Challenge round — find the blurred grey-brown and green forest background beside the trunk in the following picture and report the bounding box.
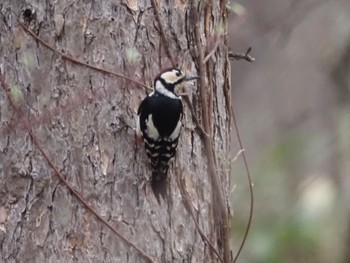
[228,0,350,263]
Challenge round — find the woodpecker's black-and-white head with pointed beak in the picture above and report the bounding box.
[154,68,199,97]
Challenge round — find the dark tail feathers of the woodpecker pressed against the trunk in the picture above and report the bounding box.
[151,163,169,204]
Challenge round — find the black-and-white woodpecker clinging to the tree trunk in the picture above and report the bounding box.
[136,68,199,204]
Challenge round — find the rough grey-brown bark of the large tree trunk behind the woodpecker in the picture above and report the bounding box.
[0,0,231,262]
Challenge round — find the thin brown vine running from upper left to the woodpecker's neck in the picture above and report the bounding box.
[17,20,152,90]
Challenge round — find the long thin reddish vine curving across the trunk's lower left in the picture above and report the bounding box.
[0,72,155,262]
